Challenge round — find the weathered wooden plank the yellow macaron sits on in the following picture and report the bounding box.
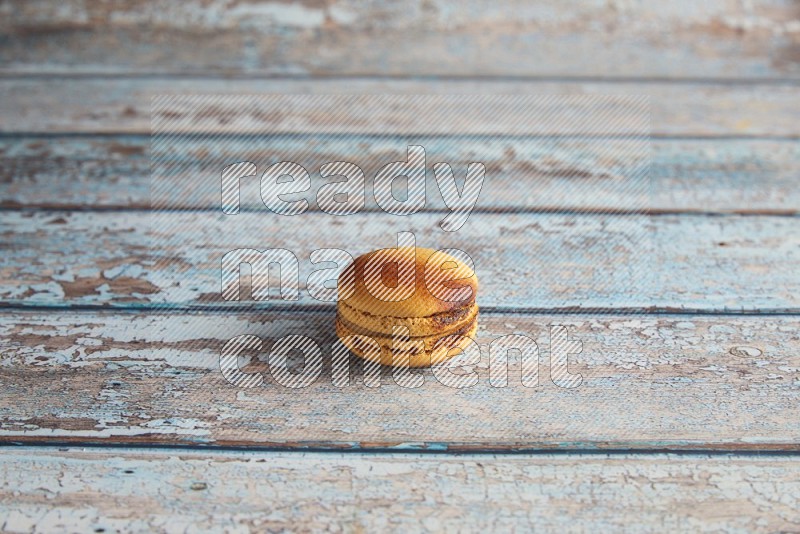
[0,311,800,451]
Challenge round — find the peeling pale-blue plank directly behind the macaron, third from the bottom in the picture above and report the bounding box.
[0,213,800,312]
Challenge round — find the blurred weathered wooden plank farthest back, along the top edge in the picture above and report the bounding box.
[0,0,800,79]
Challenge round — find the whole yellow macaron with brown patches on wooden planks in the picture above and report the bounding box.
[336,247,478,367]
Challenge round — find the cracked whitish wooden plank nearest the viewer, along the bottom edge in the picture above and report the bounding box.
[0,448,800,532]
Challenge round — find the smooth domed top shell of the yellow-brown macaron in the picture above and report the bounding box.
[338,247,478,317]
